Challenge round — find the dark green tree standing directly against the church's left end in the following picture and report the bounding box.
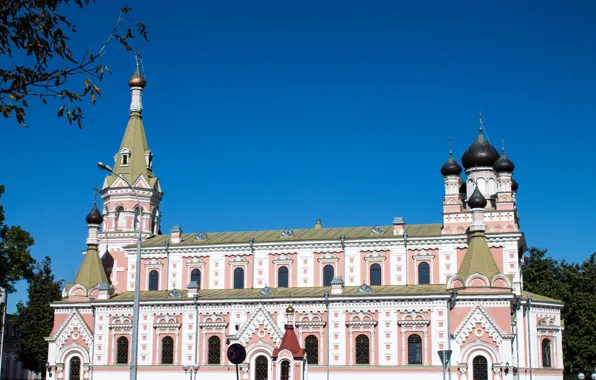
[14,256,62,378]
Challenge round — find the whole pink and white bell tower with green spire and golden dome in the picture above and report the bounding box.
[99,64,163,264]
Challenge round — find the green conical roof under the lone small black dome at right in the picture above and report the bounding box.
[457,232,500,281]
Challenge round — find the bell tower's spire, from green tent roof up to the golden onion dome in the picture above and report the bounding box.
[108,57,157,187]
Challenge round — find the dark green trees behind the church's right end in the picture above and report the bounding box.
[522,248,596,378]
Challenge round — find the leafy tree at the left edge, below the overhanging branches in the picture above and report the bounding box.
[0,185,35,293]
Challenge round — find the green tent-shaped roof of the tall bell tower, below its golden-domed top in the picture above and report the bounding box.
[108,112,156,186]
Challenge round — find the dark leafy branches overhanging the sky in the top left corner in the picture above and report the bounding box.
[0,0,147,128]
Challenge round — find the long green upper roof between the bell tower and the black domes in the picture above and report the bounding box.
[136,223,443,247]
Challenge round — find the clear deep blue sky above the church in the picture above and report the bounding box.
[0,0,596,310]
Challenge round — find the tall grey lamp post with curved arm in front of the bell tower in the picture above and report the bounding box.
[97,162,143,380]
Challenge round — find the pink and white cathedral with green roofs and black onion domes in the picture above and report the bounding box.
[46,69,563,380]
